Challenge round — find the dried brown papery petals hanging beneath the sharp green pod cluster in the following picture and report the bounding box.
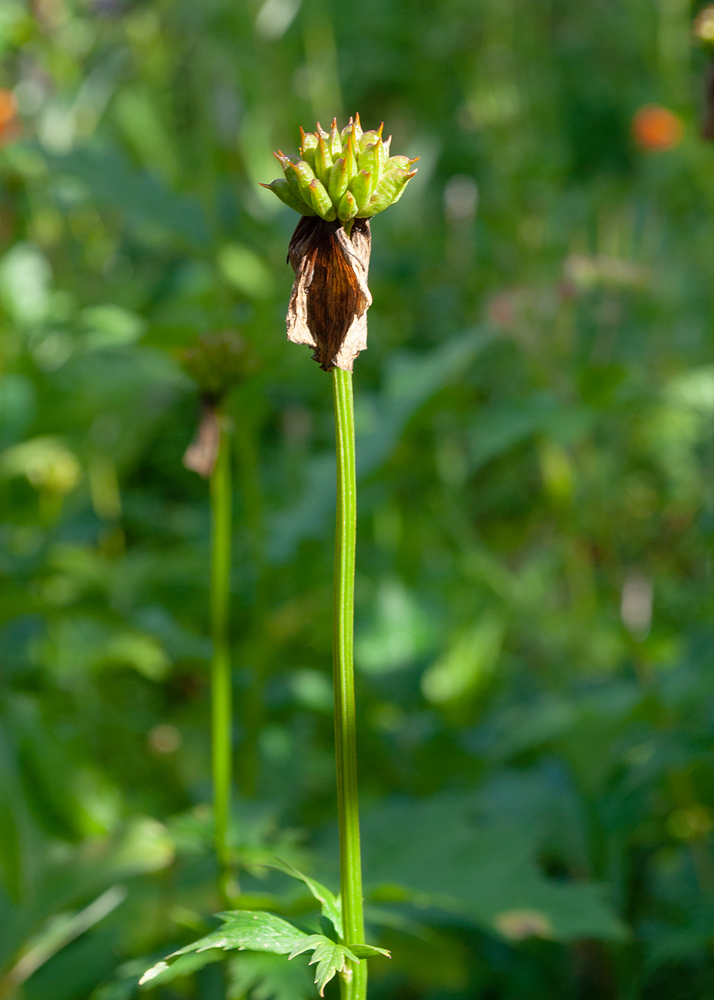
[287,217,372,371]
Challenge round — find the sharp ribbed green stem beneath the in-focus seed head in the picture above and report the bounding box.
[332,368,367,1000]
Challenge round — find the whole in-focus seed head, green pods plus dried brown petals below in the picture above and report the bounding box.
[263,115,416,371]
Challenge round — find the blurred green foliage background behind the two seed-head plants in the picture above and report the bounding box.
[0,0,714,1000]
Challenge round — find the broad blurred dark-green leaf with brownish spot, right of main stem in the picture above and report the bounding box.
[362,793,627,941]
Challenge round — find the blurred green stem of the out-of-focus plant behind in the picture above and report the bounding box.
[210,413,233,904]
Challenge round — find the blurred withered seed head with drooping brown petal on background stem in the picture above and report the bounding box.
[180,330,253,478]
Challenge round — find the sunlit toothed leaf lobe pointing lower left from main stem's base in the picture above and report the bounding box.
[139,910,305,985]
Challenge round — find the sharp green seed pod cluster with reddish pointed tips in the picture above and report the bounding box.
[262,115,419,235]
